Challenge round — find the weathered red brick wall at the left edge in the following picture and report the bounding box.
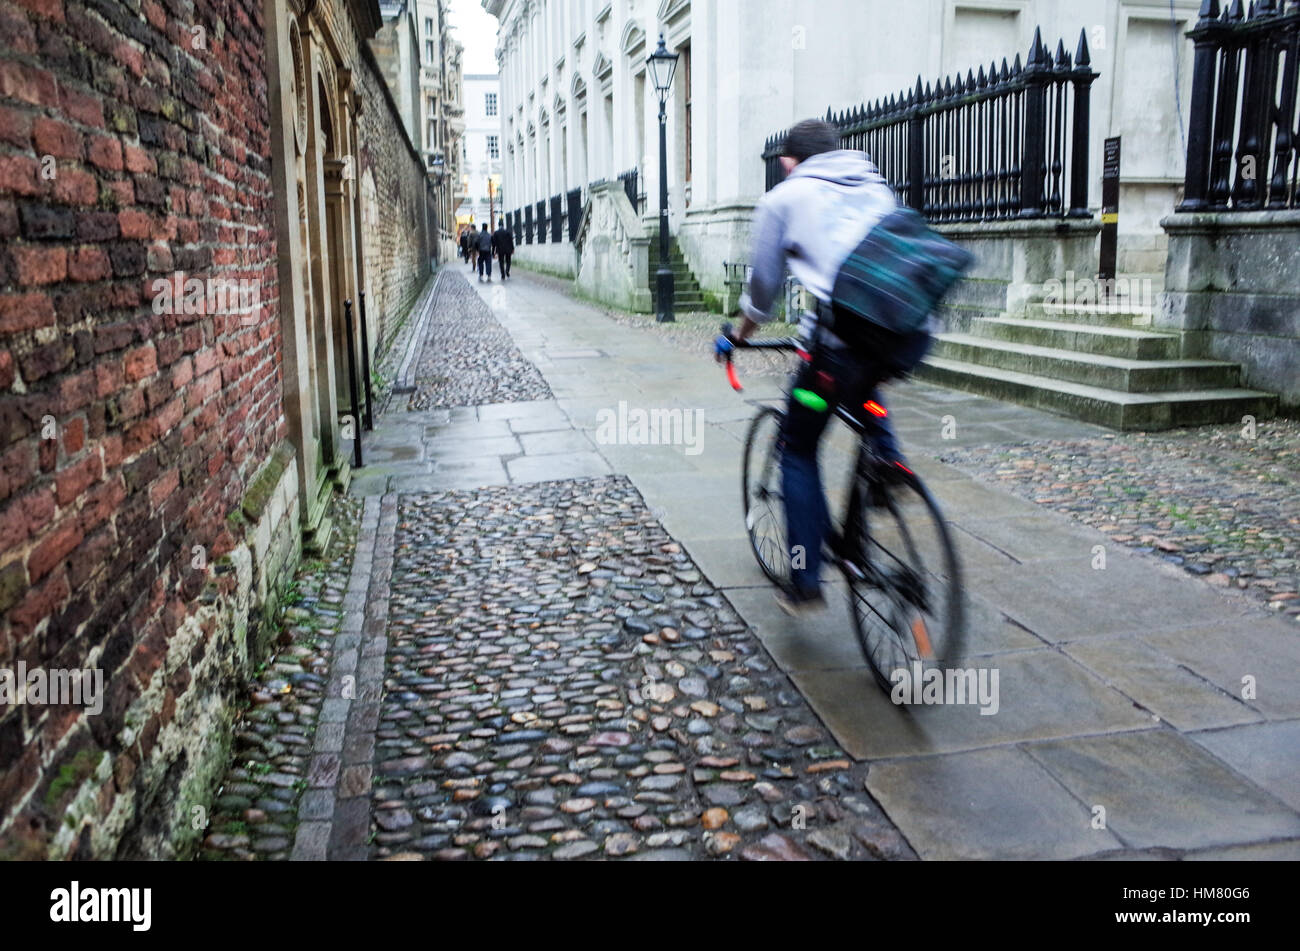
[0,0,286,854]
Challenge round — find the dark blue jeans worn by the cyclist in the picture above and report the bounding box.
[781,334,930,596]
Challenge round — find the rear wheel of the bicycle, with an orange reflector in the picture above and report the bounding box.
[845,473,965,691]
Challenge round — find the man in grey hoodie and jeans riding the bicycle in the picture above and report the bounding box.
[718,120,930,615]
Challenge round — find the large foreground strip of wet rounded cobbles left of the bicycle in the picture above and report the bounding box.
[372,477,914,860]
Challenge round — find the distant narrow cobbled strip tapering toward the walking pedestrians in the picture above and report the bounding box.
[408,271,551,409]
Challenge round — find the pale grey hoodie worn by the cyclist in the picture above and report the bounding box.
[740,149,897,335]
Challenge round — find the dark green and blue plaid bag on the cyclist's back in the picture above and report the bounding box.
[829,208,975,372]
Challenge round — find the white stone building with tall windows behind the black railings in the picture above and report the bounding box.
[482,0,1200,292]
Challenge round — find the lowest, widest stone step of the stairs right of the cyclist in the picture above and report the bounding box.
[917,356,1278,431]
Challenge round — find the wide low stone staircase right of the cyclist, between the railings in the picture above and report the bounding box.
[917,289,1278,430]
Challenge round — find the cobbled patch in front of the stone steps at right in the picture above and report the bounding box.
[941,420,1300,620]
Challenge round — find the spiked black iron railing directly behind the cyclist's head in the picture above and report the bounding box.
[763,30,1097,221]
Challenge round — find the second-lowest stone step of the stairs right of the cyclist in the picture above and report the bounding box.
[931,334,1242,392]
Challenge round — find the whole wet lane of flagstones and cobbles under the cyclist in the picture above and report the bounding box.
[205,266,1300,860]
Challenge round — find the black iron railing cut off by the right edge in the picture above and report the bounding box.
[1178,0,1300,212]
